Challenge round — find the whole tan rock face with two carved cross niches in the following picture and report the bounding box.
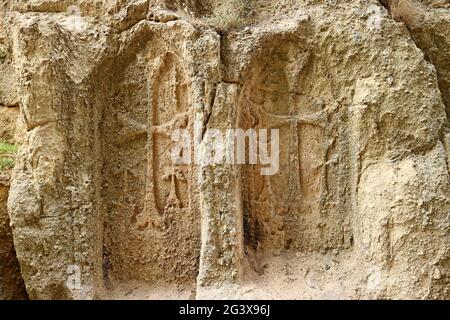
[0,0,450,299]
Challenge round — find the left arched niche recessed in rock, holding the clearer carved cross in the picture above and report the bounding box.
[103,41,200,296]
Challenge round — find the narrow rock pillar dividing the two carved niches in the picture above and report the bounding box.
[197,83,243,299]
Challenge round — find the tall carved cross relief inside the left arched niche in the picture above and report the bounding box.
[116,53,189,230]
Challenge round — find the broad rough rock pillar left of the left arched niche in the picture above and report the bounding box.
[8,13,107,299]
